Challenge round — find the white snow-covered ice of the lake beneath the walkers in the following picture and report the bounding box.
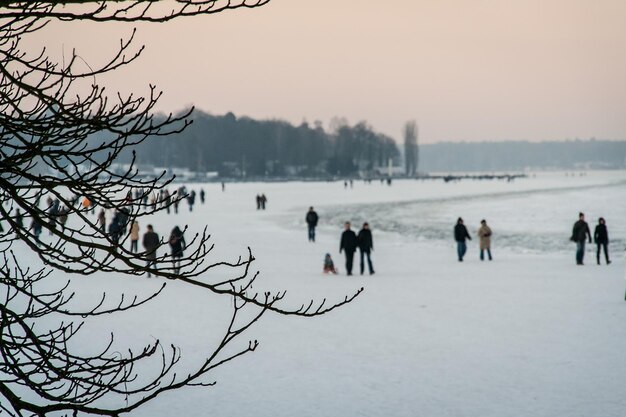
[9,172,626,417]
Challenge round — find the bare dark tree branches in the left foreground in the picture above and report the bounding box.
[0,0,361,416]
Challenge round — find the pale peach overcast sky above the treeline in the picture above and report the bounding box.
[29,0,626,143]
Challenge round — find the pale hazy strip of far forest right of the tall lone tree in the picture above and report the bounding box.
[419,139,626,173]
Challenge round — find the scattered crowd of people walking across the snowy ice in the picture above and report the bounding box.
[0,181,611,282]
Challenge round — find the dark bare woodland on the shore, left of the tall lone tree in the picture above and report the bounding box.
[126,112,400,177]
